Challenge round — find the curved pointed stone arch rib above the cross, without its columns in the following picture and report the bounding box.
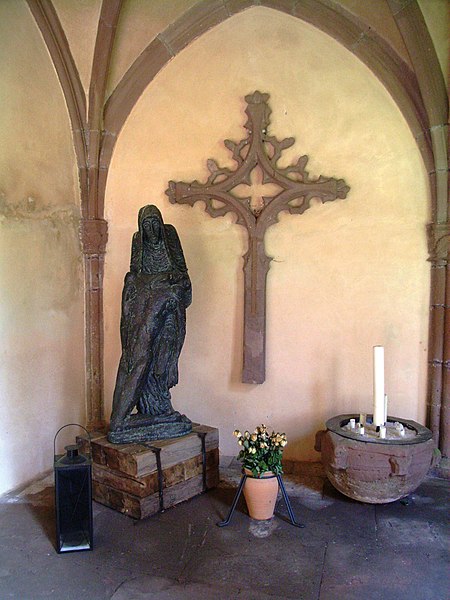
[99,0,433,209]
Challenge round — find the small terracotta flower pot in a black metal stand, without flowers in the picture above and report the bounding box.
[244,469,278,521]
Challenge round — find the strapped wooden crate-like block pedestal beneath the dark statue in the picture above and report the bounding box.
[79,425,219,519]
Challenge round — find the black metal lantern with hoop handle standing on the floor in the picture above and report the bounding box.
[53,423,93,553]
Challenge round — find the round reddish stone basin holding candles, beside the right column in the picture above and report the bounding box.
[316,414,435,504]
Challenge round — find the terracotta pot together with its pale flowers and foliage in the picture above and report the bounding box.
[234,425,287,520]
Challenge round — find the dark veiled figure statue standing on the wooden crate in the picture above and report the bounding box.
[108,205,192,443]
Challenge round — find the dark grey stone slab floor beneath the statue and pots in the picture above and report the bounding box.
[0,459,450,600]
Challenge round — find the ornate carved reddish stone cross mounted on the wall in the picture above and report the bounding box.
[166,92,350,383]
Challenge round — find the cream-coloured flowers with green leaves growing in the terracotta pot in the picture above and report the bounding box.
[234,425,287,477]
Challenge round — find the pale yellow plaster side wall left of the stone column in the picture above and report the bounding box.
[0,1,85,494]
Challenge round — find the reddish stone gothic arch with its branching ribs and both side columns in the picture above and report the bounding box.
[27,0,450,456]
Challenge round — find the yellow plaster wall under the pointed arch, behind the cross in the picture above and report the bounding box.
[104,7,429,460]
